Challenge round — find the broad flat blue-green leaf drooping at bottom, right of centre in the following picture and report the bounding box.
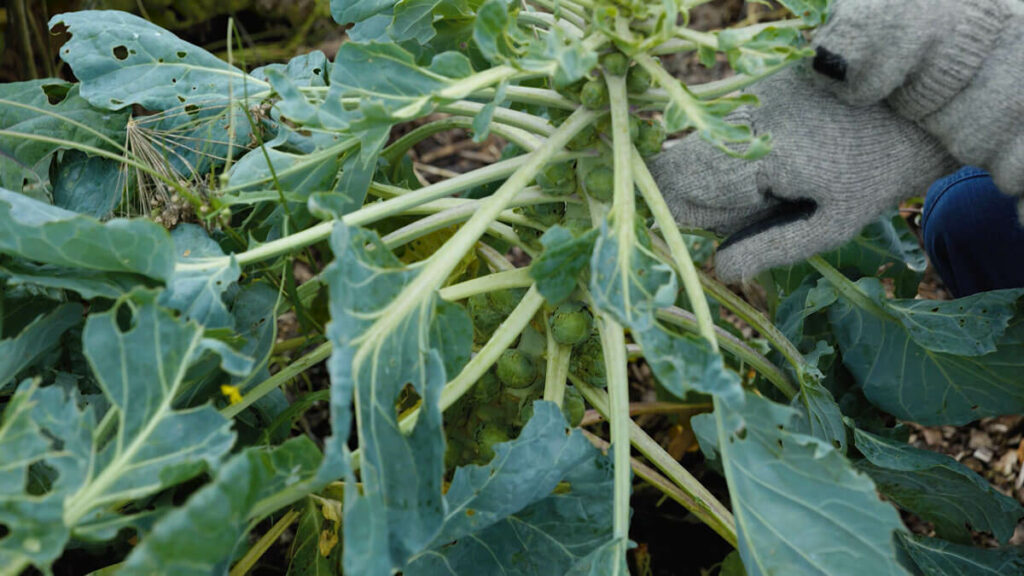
[693,394,906,576]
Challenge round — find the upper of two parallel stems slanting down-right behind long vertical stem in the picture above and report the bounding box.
[569,379,736,546]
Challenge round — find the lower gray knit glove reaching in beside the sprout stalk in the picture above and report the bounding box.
[648,70,956,282]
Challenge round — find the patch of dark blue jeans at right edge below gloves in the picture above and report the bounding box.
[921,166,1024,297]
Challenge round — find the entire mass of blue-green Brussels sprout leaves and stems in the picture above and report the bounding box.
[0,0,1024,576]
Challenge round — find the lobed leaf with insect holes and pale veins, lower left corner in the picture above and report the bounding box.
[0,291,245,569]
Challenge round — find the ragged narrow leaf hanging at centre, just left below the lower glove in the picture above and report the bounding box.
[590,224,742,399]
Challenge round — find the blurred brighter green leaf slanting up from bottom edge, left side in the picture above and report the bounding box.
[118,437,321,576]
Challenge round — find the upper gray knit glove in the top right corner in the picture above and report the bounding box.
[814,0,1024,199]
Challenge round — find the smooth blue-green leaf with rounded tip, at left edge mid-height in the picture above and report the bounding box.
[0,189,174,280]
